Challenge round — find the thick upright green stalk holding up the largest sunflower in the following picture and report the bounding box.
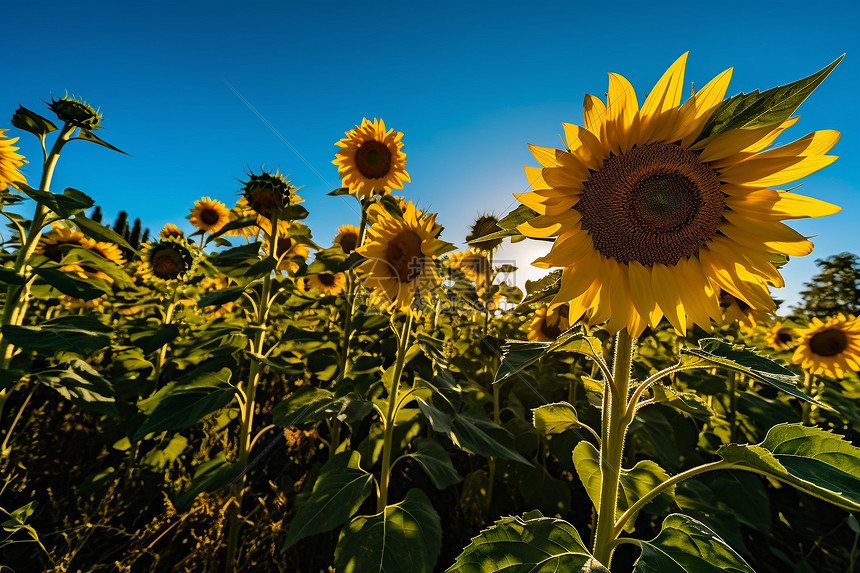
[594,330,633,567]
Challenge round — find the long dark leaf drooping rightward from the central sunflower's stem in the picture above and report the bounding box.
[416,398,531,465]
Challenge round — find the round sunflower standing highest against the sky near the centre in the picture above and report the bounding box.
[332,118,409,199]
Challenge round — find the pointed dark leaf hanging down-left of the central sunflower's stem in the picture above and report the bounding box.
[281,452,373,552]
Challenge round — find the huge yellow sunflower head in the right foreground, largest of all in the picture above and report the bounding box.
[516,54,839,336]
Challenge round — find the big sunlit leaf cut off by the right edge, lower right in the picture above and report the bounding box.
[717,424,860,511]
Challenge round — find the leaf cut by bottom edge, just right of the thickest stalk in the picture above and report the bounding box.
[633,513,755,573]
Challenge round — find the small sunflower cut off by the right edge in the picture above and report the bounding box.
[792,312,860,378]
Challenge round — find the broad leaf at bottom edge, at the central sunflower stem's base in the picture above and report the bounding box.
[334,489,442,573]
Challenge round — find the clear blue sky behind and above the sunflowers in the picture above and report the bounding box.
[0,0,860,310]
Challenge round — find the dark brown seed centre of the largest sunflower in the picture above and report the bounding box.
[574,143,726,265]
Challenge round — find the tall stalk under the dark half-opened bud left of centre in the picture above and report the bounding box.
[225,211,278,573]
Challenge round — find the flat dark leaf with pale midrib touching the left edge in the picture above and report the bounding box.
[0,316,113,353]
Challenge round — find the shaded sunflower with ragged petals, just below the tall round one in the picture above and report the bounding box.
[356,199,450,310]
